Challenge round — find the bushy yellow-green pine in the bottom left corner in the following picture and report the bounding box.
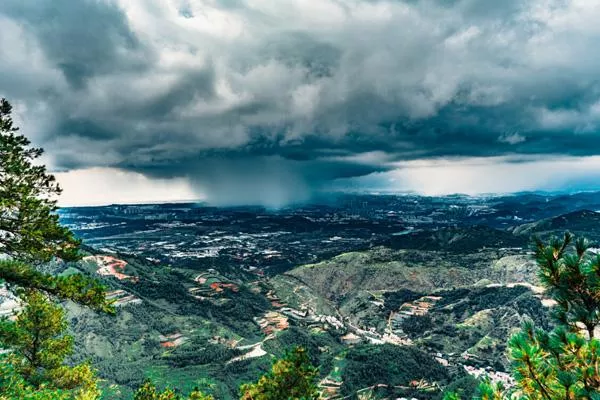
[0,290,99,399]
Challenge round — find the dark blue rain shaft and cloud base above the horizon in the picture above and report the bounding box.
[124,154,389,207]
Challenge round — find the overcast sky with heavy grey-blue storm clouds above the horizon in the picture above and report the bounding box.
[0,0,600,206]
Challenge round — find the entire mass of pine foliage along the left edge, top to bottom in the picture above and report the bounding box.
[0,99,113,400]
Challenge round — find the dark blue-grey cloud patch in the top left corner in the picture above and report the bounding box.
[1,0,144,88]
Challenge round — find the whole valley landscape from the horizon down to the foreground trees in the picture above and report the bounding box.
[11,193,600,399]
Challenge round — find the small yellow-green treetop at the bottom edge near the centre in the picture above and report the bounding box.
[240,347,319,400]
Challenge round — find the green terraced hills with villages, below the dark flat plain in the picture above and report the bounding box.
[61,238,543,399]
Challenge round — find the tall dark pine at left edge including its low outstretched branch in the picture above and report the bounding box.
[0,99,111,311]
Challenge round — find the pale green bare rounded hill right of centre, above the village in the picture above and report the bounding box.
[288,248,536,301]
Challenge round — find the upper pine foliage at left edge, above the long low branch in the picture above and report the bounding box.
[0,99,79,262]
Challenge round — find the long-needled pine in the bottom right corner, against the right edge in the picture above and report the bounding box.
[445,233,600,400]
